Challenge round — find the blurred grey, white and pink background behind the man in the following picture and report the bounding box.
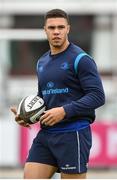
[0,0,117,179]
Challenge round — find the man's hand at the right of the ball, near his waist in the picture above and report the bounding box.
[40,107,65,126]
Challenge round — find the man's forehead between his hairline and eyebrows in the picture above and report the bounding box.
[45,17,68,26]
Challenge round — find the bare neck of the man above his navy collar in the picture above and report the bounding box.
[50,40,69,55]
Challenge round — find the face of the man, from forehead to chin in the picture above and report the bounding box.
[44,18,70,48]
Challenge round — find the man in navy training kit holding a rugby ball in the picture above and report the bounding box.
[11,9,105,179]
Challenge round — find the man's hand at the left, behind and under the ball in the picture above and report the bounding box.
[10,107,30,128]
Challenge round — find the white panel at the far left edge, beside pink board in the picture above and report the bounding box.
[0,111,19,166]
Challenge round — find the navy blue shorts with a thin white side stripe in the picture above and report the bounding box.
[27,126,92,174]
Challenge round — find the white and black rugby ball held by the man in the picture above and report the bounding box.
[17,95,46,124]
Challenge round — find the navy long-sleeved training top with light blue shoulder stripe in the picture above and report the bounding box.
[37,43,105,131]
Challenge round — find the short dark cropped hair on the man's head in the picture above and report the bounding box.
[44,9,70,24]
